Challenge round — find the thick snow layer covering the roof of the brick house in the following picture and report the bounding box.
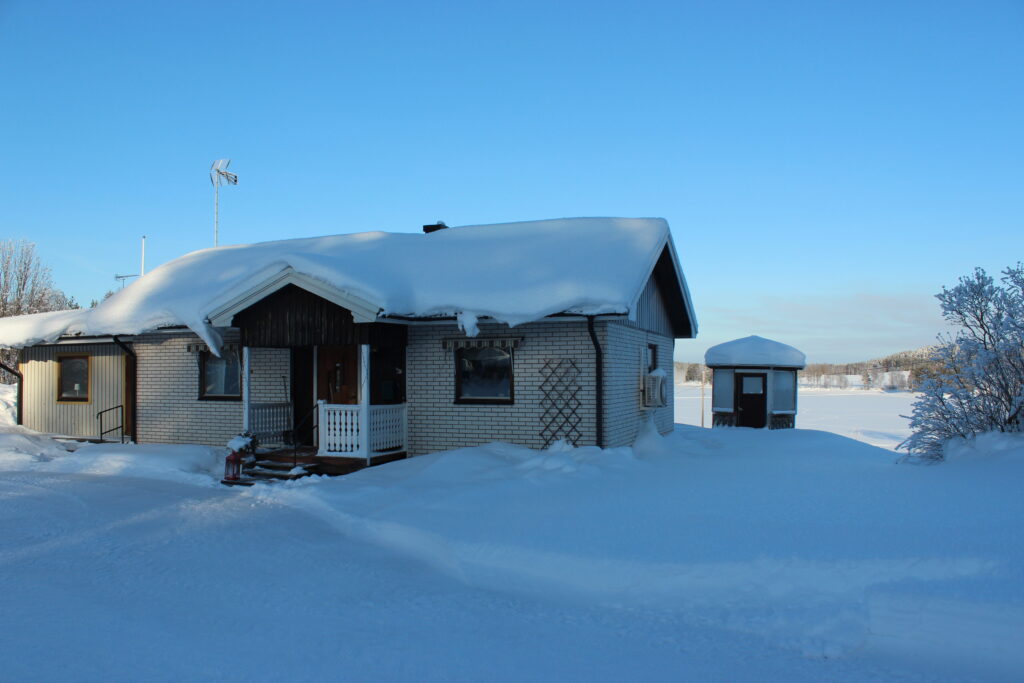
[0,218,696,347]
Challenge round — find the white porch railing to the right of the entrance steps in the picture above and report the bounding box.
[318,402,406,458]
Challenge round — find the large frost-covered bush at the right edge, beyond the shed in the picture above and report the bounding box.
[899,263,1024,462]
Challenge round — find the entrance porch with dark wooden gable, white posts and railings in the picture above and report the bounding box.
[218,283,409,485]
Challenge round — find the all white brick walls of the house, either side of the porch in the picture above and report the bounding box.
[134,321,673,455]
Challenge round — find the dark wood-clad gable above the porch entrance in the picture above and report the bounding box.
[231,285,407,348]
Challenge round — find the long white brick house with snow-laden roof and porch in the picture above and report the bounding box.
[0,218,696,458]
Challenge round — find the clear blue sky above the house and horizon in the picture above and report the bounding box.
[0,0,1024,361]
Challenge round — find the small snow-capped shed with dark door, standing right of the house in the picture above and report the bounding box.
[705,336,807,429]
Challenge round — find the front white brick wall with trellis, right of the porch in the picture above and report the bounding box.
[406,322,596,455]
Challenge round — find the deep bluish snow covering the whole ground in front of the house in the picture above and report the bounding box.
[0,392,1024,681]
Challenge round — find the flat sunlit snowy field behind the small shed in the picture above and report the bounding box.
[676,384,914,449]
